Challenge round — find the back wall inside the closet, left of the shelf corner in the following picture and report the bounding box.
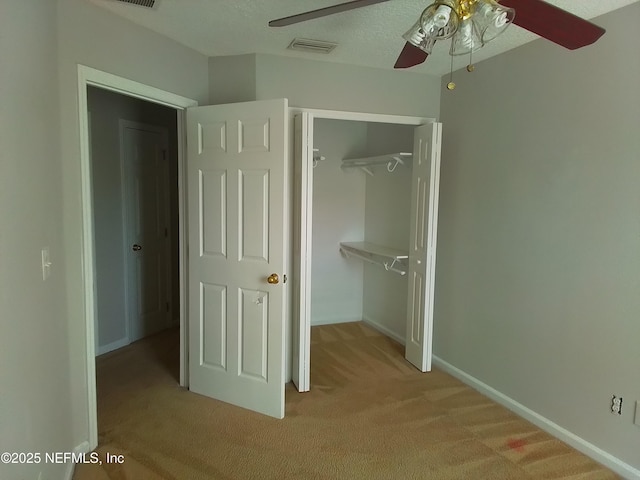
[311,119,367,325]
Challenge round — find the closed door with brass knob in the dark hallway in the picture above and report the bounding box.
[120,120,171,342]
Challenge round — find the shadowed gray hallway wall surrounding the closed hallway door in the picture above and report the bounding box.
[88,87,180,353]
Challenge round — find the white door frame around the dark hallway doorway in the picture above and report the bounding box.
[78,65,198,450]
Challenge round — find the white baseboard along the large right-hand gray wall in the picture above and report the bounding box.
[433,355,640,480]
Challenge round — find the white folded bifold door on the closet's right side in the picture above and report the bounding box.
[405,123,442,372]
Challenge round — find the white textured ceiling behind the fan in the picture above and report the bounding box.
[89,0,640,76]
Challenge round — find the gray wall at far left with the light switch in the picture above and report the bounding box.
[0,0,75,479]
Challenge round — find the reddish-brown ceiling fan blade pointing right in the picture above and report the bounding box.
[500,0,605,50]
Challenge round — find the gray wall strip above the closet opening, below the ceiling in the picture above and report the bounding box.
[209,54,440,117]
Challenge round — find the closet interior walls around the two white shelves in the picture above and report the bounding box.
[311,119,414,342]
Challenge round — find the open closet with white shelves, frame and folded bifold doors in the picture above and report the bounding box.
[292,111,441,391]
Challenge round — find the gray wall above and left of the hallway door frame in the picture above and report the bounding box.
[56,0,209,454]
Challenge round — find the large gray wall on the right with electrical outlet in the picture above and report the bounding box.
[434,3,640,468]
